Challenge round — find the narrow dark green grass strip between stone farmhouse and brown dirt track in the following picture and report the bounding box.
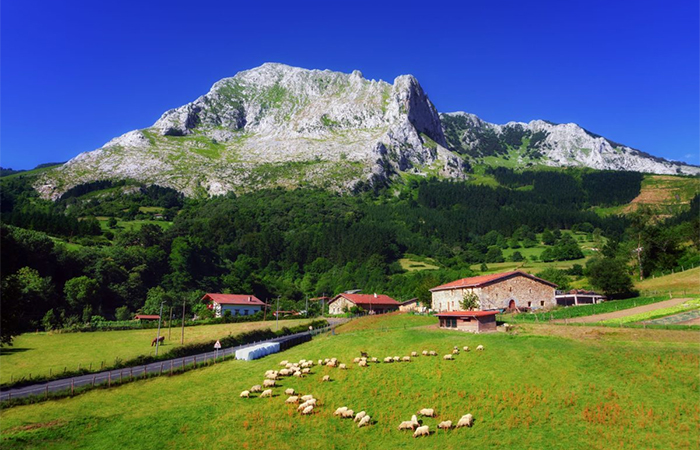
[497,295,680,322]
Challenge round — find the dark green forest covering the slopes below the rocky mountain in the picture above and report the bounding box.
[0,169,700,342]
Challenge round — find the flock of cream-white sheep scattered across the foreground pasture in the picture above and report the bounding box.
[240,345,484,438]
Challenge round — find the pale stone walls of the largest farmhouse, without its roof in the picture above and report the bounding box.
[433,276,556,312]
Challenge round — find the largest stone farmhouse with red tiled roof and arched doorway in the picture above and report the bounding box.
[430,270,557,312]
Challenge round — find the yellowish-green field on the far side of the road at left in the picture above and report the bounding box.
[0,320,308,383]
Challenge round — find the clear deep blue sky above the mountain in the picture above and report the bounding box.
[0,0,700,169]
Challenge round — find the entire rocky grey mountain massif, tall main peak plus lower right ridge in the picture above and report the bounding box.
[35,63,700,199]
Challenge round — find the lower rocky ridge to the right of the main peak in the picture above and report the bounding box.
[440,112,700,175]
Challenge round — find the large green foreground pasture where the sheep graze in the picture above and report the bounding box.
[0,316,700,449]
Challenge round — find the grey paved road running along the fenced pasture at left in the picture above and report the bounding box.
[0,319,344,401]
